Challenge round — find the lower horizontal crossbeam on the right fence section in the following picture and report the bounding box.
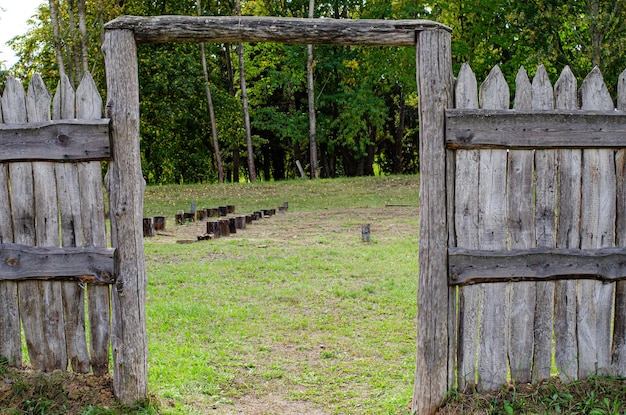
[448,248,626,285]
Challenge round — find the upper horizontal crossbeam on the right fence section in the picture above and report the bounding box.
[446,110,626,149]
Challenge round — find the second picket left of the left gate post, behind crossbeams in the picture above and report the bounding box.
[52,75,90,373]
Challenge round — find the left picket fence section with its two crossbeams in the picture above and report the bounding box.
[0,74,114,375]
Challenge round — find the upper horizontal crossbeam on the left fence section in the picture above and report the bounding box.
[0,119,111,162]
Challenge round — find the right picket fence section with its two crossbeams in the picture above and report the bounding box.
[446,65,626,390]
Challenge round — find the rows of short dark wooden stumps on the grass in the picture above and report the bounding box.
[143,202,289,240]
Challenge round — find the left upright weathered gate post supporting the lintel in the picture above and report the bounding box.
[102,30,148,404]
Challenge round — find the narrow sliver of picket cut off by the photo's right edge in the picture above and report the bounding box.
[611,70,626,376]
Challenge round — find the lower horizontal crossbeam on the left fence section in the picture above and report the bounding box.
[0,243,115,284]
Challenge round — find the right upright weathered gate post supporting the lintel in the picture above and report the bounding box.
[412,29,453,415]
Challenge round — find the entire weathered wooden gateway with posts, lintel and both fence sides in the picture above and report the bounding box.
[7,11,626,414]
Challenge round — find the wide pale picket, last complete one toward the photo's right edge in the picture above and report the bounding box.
[577,67,616,378]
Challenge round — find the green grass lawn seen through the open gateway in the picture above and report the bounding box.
[146,176,419,414]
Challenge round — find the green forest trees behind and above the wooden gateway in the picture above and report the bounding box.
[0,0,626,184]
